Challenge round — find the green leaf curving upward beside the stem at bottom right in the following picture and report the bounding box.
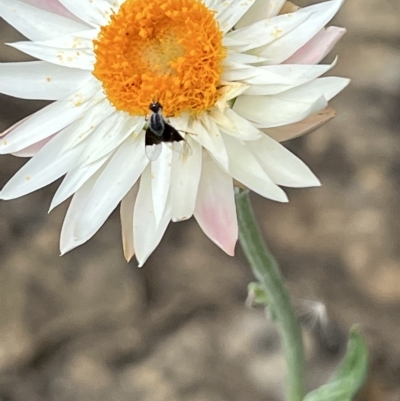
[303,327,368,401]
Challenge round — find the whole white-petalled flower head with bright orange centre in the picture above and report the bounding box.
[0,0,348,265]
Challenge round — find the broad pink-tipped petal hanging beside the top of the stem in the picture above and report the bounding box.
[194,151,238,256]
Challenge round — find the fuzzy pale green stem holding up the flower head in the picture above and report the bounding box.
[236,190,305,401]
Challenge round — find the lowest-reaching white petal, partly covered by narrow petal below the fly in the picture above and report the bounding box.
[133,166,171,267]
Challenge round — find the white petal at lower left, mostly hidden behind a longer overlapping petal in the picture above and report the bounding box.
[60,170,101,255]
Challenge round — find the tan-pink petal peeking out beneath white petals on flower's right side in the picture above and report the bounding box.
[261,106,336,142]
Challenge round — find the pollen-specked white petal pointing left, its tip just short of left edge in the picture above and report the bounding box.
[8,29,97,71]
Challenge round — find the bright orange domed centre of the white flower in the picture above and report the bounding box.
[93,0,226,116]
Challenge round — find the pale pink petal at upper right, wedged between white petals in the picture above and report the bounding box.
[283,26,346,64]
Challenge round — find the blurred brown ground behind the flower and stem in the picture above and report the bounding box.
[0,0,400,401]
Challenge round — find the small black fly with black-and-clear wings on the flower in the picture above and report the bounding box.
[145,102,190,161]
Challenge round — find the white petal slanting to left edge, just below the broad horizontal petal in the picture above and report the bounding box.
[0,82,101,154]
